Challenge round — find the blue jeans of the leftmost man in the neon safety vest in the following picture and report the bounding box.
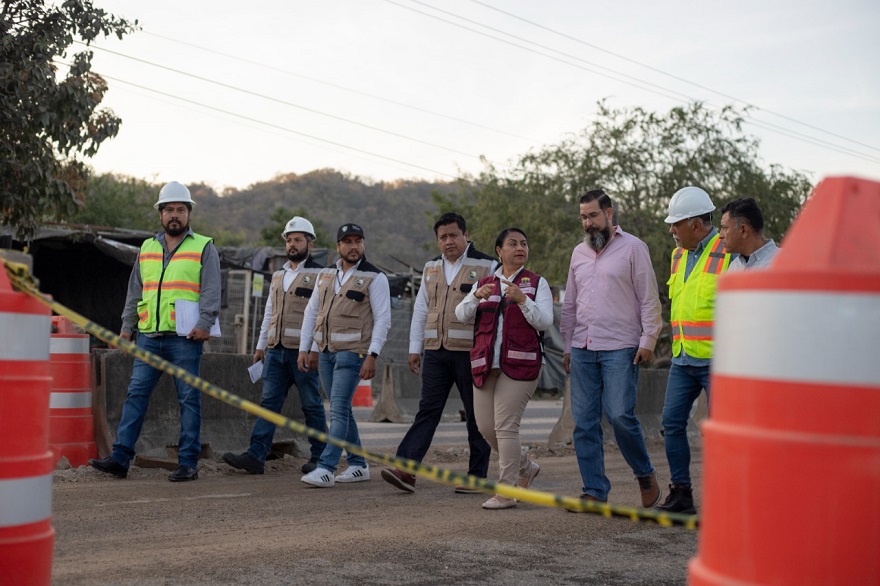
[110,335,204,468]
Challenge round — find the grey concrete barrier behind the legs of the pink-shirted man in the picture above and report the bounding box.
[547,368,708,447]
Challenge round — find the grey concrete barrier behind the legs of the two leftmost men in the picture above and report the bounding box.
[92,350,309,457]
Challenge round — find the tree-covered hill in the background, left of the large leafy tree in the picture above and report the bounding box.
[69,169,451,271]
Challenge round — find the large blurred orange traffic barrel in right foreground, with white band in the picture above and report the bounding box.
[689,177,880,585]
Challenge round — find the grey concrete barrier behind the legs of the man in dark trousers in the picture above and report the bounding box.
[370,362,464,423]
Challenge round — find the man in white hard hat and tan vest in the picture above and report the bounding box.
[223,216,327,474]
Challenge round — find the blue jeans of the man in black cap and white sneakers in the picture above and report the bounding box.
[318,350,367,472]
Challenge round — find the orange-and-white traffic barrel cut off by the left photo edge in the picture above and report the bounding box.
[0,269,55,584]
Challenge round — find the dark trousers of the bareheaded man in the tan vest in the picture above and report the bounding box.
[397,348,492,478]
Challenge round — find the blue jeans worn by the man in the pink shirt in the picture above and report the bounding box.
[570,348,654,501]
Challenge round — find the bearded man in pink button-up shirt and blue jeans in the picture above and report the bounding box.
[559,189,662,507]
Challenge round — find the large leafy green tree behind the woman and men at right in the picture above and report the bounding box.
[434,101,812,293]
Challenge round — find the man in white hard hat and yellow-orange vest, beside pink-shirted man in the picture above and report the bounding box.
[657,186,730,514]
